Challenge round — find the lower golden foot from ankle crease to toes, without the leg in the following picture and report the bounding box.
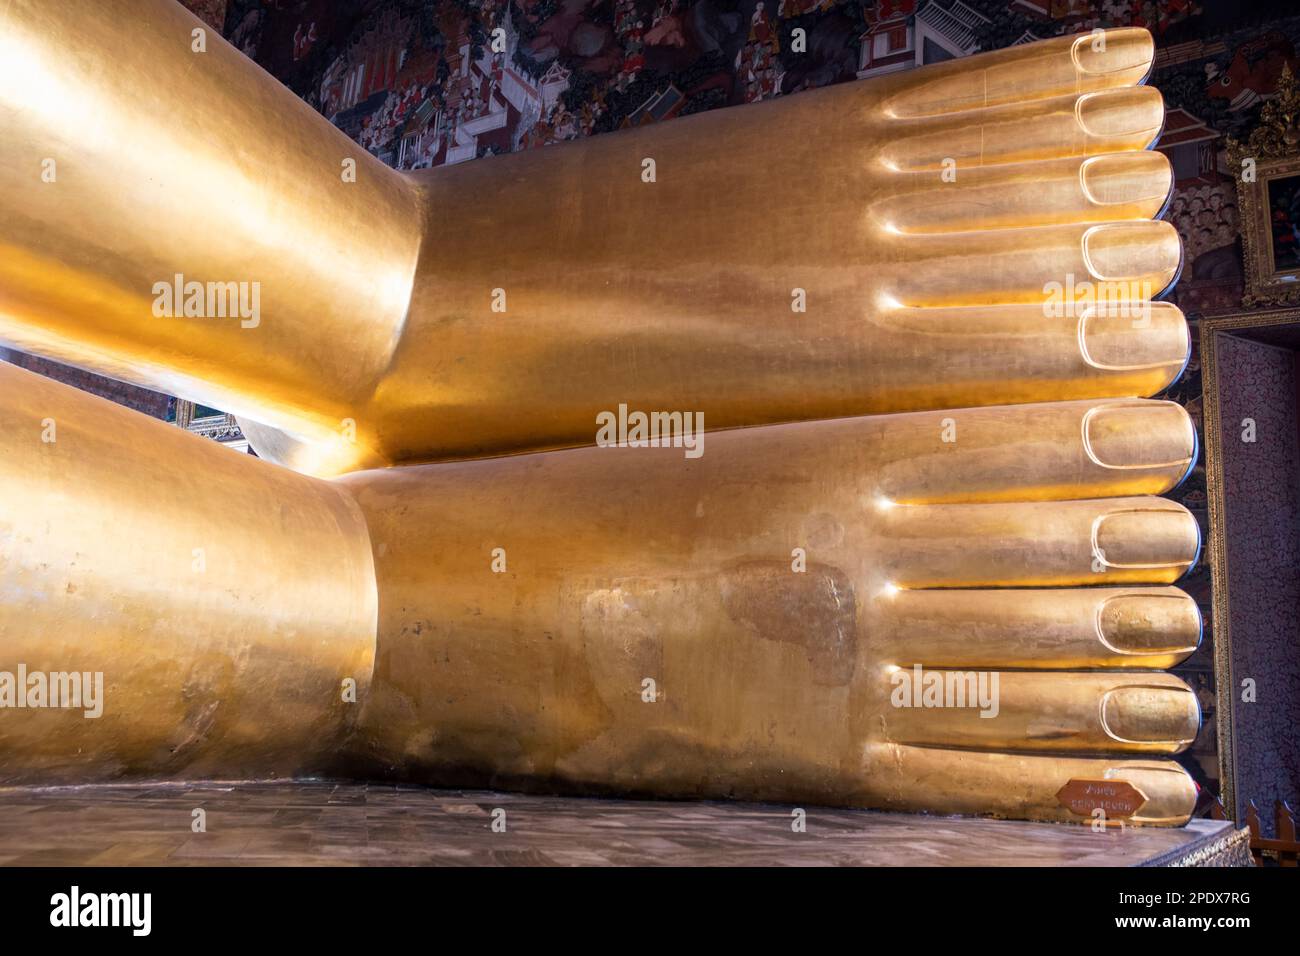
[342,399,1200,825]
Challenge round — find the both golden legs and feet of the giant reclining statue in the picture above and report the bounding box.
[0,0,1201,825]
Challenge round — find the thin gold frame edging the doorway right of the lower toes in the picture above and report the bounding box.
[1200,308,1300,821]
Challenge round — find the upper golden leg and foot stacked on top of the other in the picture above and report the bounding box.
[0,0,1190,475]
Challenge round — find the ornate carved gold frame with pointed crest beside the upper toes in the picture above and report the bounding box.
[1227,68,1300,306]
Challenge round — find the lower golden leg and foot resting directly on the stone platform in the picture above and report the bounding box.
[0,367,1200,825]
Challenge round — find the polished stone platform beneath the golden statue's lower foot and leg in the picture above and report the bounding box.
[0,782,1249,866]
